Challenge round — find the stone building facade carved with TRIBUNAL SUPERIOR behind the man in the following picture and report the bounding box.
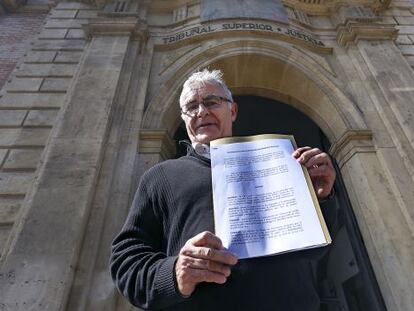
[0,0,414,311]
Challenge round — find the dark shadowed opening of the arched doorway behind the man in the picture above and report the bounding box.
[174,95,386,311]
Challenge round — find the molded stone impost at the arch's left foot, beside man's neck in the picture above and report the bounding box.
[138,129,176,159]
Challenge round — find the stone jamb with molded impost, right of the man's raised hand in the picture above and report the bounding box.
[331,131,414,311]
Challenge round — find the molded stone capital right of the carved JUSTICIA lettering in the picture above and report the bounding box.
[336,20,398,47]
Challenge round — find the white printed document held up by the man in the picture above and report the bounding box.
[210,135,331,259]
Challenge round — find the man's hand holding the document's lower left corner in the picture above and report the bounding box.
[175,231,237,296]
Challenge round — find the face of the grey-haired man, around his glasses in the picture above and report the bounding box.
[181,84,237,144]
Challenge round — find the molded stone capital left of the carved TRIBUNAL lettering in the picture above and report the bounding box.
[82,17,147,40]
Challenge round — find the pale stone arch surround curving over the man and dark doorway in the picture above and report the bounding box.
[139,37,414,310]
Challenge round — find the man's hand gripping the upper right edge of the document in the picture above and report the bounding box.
[292,147,336,199]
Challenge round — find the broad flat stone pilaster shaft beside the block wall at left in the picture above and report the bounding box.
[0,22,130,311]
